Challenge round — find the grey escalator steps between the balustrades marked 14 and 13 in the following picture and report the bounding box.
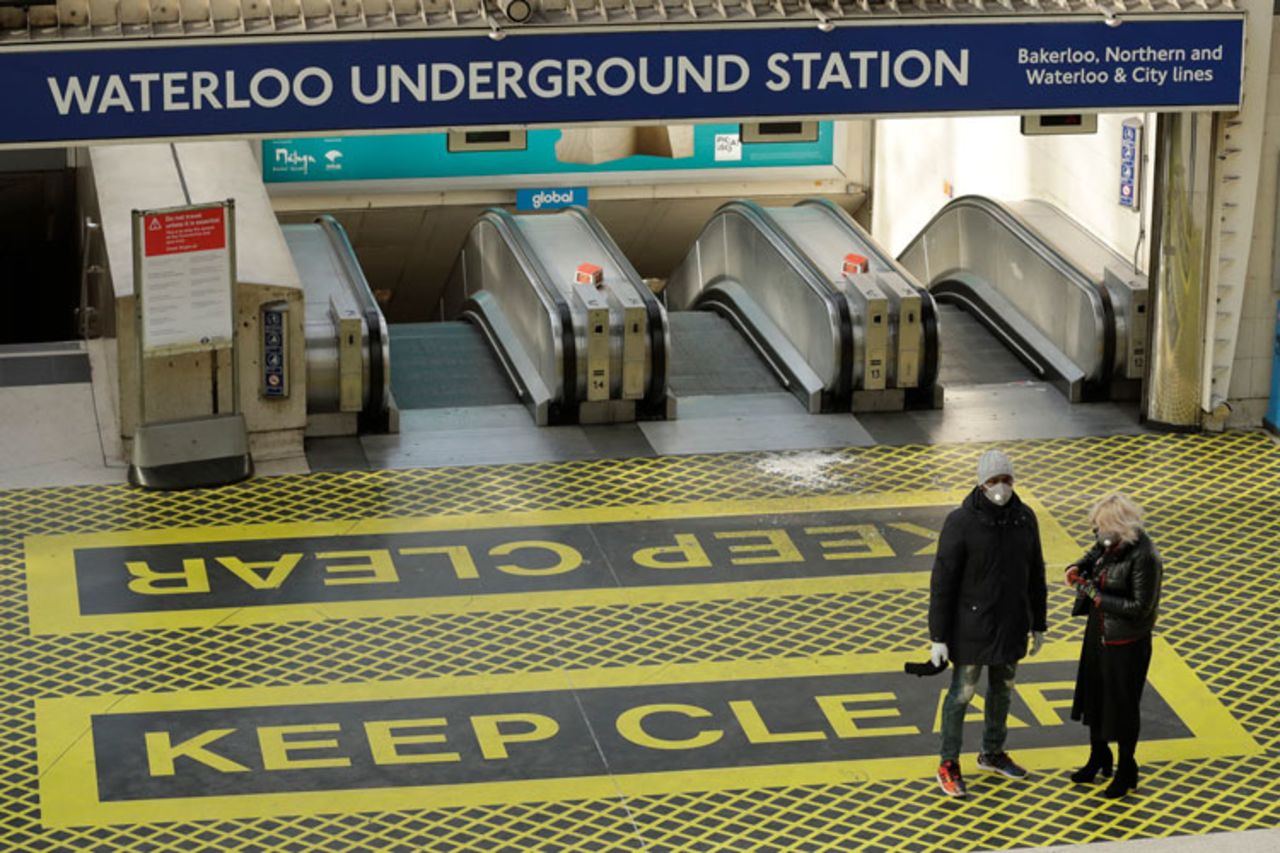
[668,311,778,397]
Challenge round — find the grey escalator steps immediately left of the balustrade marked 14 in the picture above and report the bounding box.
[390,321,520,409]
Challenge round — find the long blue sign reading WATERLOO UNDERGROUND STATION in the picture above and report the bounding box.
[0,15,1244,145]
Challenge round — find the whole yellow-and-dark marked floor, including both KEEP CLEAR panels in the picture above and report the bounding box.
[0,433,1280,850]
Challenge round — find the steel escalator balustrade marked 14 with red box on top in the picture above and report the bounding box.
[442,207,669,425]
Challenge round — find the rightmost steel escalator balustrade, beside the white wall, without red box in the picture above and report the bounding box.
[899,196,1147,402]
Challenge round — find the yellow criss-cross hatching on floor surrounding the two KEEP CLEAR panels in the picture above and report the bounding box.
[0,433,1280,850]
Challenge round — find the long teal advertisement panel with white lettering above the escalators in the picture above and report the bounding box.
[262,122,835,183]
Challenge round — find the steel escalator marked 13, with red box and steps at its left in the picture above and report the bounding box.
[666,200,937,414]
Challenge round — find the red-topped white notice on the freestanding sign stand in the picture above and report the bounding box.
[133,202,234,355]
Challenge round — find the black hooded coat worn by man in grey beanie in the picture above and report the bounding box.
[929,487,1047,663]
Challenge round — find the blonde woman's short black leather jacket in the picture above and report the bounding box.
[1071,533,1165,643]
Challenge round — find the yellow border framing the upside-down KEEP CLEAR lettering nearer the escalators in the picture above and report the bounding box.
[26,491,1080,634]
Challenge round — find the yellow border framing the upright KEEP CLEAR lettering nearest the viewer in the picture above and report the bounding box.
[36,639,1260,826]
